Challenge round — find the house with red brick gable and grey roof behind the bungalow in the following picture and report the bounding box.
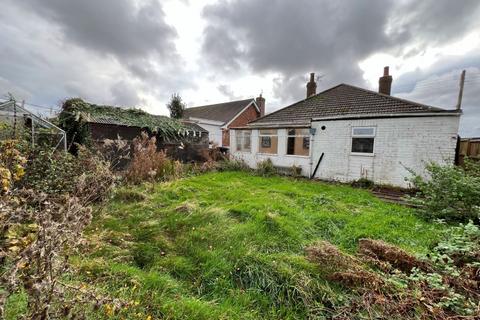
[183,95,265,148]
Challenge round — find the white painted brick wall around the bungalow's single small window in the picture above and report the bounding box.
[312,116,460,187]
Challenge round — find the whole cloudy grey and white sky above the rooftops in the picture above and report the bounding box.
[0,0,480,136]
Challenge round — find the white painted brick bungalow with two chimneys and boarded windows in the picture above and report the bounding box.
[230,67,462,187]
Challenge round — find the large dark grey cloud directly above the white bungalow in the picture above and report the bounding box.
[203,0,390,83]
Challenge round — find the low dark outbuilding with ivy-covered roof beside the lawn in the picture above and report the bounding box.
[58,98,209,161]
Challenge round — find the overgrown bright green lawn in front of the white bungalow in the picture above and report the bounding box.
[74,172,443,319]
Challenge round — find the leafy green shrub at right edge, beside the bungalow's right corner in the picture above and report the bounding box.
[411,163,480,222]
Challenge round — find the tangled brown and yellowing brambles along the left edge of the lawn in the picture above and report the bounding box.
[0,140,116,319]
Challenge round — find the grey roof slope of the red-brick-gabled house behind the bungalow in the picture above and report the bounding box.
[183,98,254,123]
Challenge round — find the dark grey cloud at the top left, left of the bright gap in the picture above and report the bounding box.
[17,0,176,58]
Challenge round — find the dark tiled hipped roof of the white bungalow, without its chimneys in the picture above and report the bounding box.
[250,83,456,125]
